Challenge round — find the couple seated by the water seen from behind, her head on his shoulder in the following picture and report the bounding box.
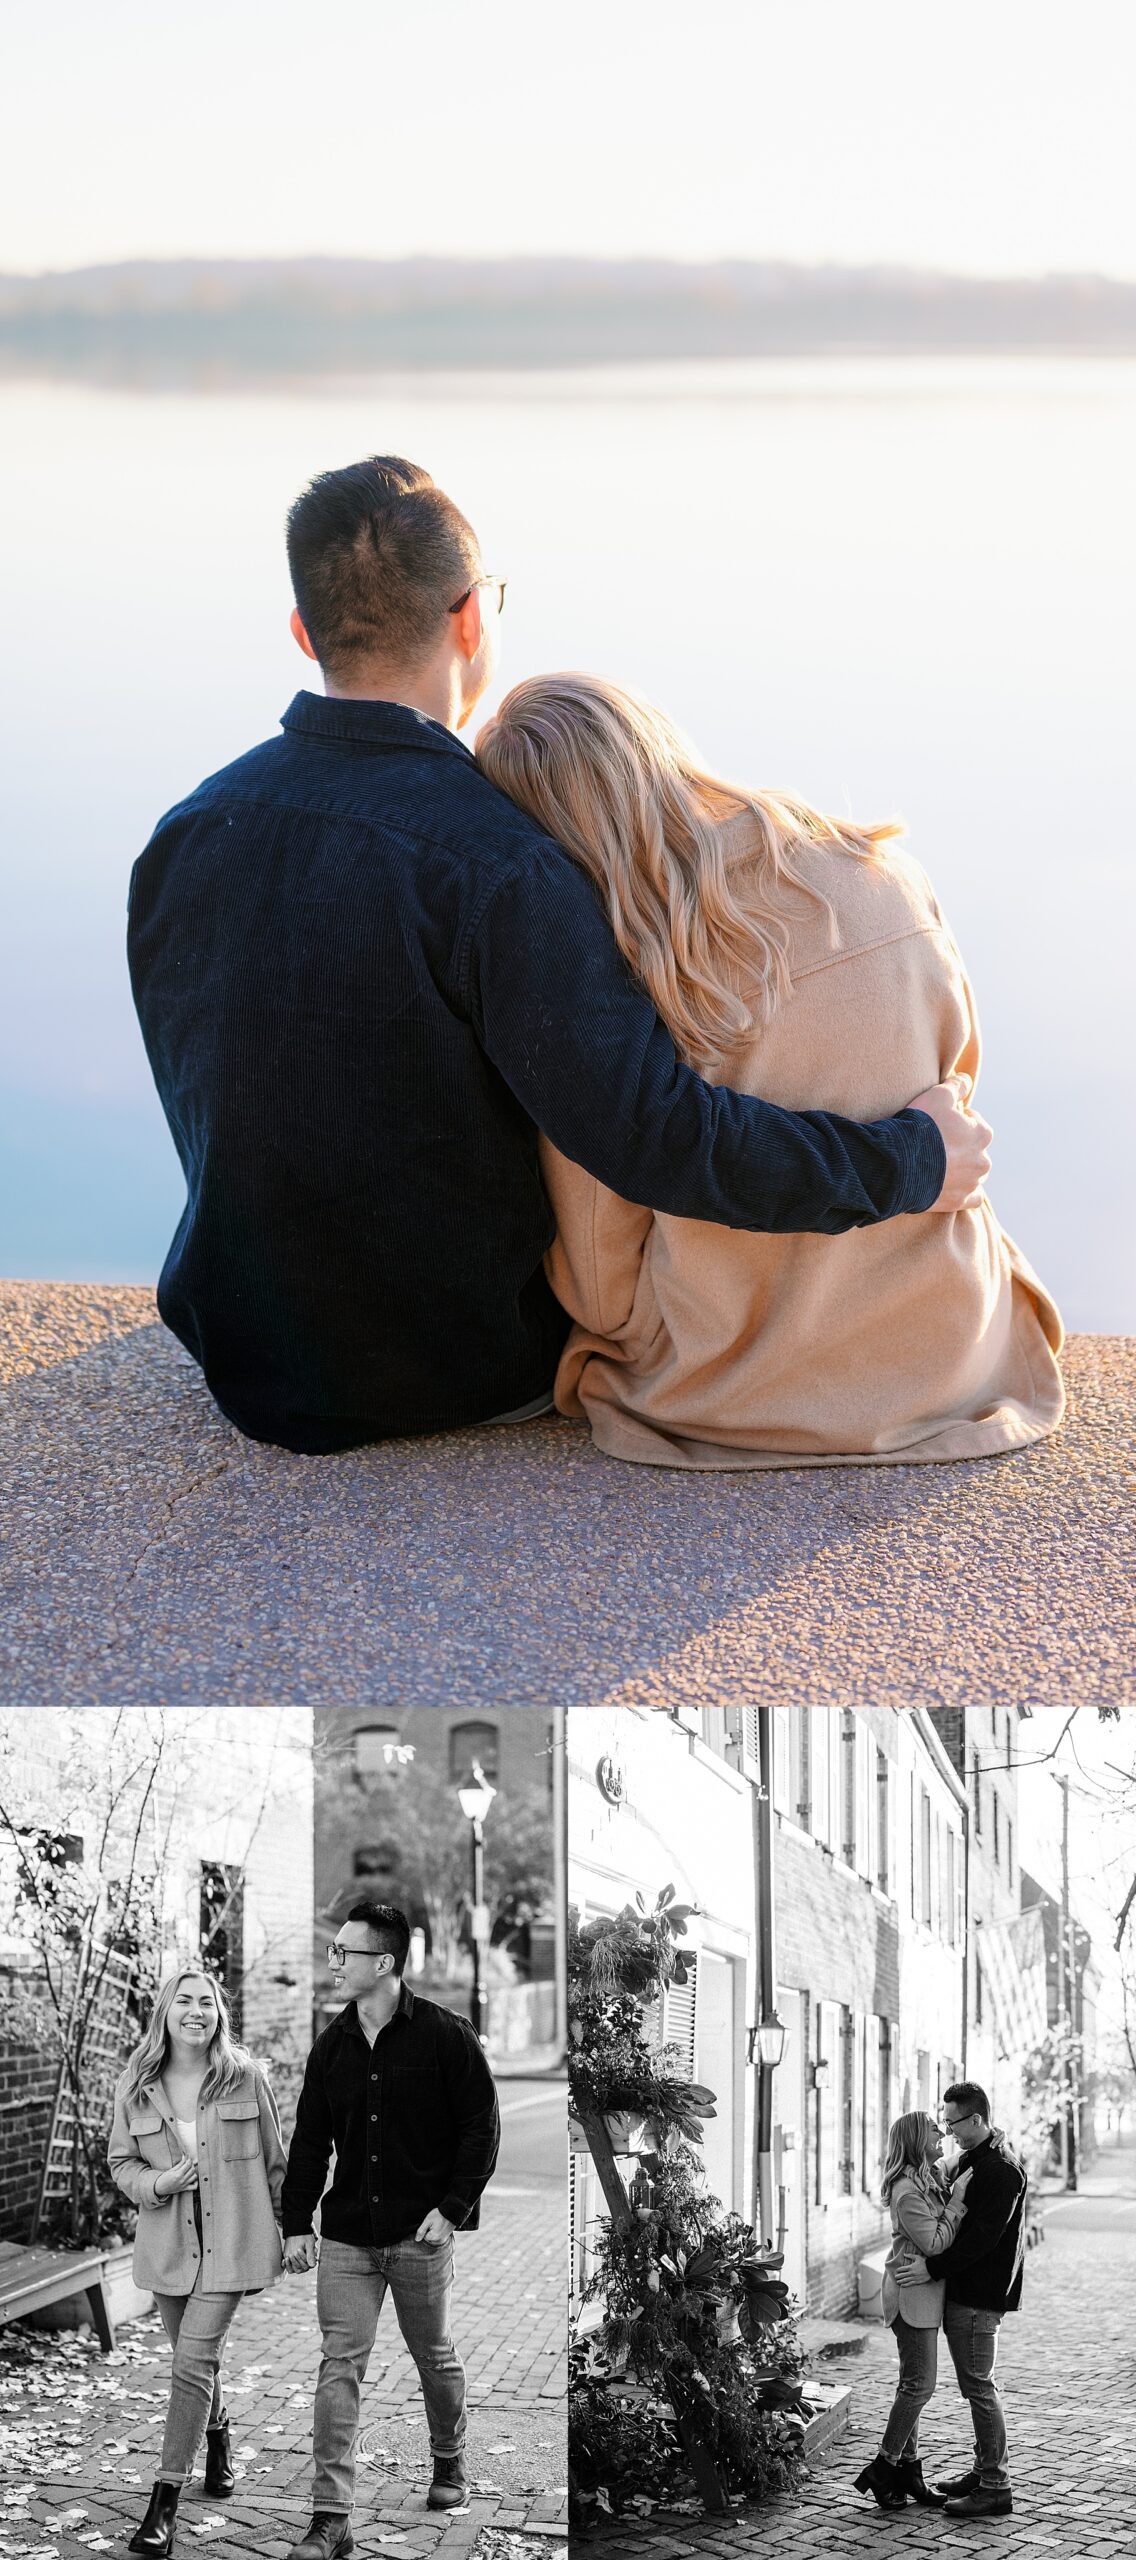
[128,456,1062,1469]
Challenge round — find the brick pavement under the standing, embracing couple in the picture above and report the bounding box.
[585,2220,1136,2560]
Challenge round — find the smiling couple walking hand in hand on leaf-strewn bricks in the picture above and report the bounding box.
[107,1902,499,2560]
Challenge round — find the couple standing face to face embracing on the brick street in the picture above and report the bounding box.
[855,2081,1026,2516]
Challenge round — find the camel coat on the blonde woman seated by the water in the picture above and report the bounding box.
[540,812,1064,1467]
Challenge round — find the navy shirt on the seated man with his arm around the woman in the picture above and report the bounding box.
[128,694,944,1452]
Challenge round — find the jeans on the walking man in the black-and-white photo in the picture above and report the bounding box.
[312,2240,466,2516]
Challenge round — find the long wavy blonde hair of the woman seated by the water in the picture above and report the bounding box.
[476,673,903,1078]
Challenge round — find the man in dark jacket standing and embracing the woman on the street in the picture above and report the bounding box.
[926,2081,1026,2516]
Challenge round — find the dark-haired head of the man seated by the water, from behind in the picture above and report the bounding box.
[287,453,478,676]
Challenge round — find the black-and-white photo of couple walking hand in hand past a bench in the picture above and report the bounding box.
[0,1708,565,2560]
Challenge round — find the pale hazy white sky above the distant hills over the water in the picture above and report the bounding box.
[0,0,1136,276]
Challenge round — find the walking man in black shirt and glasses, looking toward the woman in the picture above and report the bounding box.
[281,1902,501,2560]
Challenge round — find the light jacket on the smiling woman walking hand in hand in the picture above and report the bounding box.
[107,2068,287,2294]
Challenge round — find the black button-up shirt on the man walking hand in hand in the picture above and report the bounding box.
[281,1984,501,2248]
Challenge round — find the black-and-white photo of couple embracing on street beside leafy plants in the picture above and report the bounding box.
[568,1708,1136,2560]
